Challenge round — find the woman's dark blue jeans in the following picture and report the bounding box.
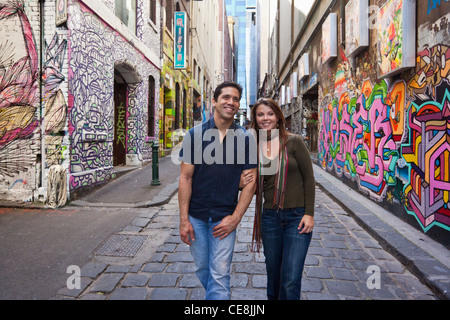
[262,208,312,300]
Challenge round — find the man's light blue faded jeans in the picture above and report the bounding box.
[189,216,236,300]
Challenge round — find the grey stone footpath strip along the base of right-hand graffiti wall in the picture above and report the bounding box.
[314,165,450,300]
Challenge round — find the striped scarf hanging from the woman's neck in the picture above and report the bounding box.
[252,141,289,252]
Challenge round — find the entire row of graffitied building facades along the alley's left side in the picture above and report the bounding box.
[0,0,234,206]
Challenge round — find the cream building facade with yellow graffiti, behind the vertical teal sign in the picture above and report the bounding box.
[159,0,233,143]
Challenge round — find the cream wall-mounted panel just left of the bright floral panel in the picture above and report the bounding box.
[345,0,369,57]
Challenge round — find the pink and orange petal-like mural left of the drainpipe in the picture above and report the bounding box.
[0,1,40,201]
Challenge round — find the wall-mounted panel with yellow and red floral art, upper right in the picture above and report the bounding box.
[377,0,416,78]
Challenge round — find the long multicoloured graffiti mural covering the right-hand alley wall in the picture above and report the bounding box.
[318,45,450,232]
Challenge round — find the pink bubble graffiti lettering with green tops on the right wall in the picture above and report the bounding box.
[319,76,398,201]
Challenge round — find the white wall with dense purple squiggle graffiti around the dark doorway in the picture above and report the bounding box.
[68,1,159,189]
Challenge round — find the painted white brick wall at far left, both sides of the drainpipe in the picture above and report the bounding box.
[0,0,68,201]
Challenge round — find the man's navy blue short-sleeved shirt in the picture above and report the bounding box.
[179,118,257,222]
